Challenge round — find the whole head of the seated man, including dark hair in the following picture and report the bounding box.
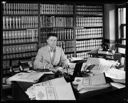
[47,33,57,48]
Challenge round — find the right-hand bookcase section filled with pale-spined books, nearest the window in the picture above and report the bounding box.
[75,4,103,58]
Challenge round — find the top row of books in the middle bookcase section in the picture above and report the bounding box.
[40,4,73,14]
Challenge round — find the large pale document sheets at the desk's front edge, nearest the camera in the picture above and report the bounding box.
[26,77,75,100]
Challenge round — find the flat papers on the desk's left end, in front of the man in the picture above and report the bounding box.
[8,71,53,83]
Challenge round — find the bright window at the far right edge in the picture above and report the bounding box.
[117,5,126,54]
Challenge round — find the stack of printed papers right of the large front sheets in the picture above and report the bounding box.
[73,73,110,93]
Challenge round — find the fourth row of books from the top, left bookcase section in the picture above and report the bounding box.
[3,43,37,54]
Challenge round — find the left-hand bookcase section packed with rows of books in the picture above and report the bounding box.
[3,3,38,74]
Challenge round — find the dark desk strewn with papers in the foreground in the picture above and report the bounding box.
[12,72,125,102]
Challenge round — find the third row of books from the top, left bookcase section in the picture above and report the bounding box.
[3,31,38,44]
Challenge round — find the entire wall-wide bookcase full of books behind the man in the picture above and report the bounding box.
[3,3,103,74]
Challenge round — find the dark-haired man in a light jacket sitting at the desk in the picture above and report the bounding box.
[34,33,69,71]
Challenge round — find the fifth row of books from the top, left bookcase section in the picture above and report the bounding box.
[3,51,37,60]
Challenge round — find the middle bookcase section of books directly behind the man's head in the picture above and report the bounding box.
[40,4,75,57]
